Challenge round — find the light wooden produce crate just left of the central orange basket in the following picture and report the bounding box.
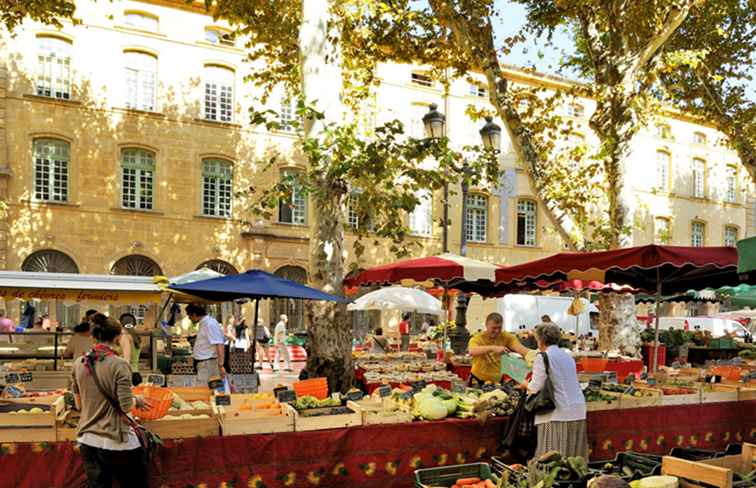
[213,393,294,436]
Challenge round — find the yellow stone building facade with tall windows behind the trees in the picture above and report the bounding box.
[0,0,754,332]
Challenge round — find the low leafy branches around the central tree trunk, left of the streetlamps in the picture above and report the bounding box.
[244,104,499,266]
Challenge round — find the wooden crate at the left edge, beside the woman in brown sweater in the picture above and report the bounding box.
[0,396,65,442]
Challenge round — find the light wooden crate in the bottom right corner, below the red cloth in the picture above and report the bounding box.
[662,444,756,488]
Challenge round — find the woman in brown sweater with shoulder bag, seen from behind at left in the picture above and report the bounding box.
[72,318,149,488]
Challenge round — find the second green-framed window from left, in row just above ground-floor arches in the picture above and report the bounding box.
[121,148,155,210]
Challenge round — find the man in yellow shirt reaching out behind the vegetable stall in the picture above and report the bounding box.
[468,313,531,384]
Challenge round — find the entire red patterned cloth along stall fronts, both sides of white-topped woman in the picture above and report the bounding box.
[0,401,756,488]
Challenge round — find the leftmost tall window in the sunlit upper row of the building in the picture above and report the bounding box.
[36,36,72,100]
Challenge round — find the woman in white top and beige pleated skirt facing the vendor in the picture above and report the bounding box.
[528,323,588,459]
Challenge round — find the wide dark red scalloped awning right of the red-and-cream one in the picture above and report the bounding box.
[496,245,739,294]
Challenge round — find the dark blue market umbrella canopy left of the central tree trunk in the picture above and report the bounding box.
[168,269,348,302]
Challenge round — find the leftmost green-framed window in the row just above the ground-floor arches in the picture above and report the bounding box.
[33,139,70,202]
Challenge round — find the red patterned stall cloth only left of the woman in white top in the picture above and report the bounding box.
[0,419,505,488]
